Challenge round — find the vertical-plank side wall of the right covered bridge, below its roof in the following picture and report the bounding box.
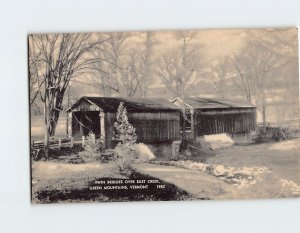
[195,109,256,136]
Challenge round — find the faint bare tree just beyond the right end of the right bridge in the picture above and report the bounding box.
[233,31,292,125]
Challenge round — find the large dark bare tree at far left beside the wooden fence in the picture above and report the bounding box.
[29,34,103,157]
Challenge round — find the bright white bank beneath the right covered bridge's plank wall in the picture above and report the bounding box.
[200,133,234,150]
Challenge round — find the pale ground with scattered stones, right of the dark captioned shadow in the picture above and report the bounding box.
[135,138,300,199]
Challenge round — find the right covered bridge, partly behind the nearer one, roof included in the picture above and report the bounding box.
[172,97,256,136]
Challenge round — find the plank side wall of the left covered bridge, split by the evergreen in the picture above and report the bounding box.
[105,112,180,148]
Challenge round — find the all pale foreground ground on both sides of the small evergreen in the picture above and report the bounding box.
[32,138,300,200]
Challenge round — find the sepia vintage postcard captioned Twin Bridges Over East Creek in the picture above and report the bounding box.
[28,28,300,203]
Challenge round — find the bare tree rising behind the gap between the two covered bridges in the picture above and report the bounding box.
[157,31,200,142]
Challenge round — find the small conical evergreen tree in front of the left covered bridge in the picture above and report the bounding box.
[114,102,137,146]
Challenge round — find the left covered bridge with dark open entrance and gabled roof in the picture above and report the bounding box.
[68,97,180,148]
